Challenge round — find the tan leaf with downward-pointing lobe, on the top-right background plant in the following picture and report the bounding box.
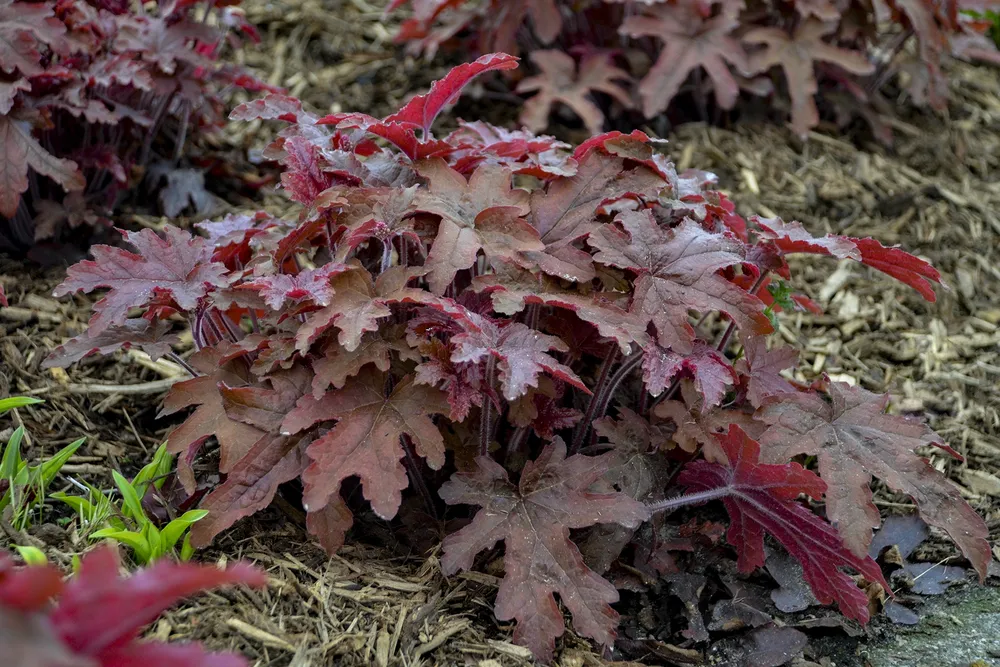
[743,19,875,137]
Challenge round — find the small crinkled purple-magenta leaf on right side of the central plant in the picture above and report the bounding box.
[642,342,738,412]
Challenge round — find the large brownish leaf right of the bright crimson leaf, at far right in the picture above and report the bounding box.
[757,382,991,577]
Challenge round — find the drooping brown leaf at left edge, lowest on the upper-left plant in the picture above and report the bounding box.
[0,115,86,218]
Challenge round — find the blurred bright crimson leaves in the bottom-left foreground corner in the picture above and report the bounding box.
[0,547,267,667]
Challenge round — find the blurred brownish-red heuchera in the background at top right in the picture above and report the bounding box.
[387,0,1000,136]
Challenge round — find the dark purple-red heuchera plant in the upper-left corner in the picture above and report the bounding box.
[0,0,263,246]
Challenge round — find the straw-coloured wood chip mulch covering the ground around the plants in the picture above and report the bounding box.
[0,0,1000,667]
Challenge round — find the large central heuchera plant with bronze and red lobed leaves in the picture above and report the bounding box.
[47,54,990,659]
